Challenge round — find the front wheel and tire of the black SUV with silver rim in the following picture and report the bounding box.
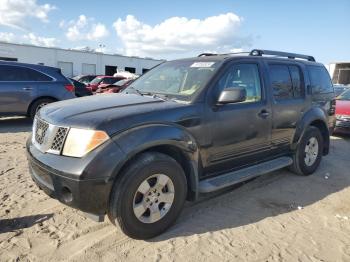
[107,152,187,239]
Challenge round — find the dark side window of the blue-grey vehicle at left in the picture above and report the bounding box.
[0,65,52,81]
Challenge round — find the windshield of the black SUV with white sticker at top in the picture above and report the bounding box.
[126,61,219,98]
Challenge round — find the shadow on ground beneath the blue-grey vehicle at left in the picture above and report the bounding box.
[0,117,33,133]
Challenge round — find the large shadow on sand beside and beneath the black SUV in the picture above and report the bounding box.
[148,136,350,242]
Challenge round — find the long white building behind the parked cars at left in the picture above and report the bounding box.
[0,42,163,77]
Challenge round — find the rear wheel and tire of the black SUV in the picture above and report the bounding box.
[290,126,323,176]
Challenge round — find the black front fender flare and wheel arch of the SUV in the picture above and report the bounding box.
[112,124,199,200]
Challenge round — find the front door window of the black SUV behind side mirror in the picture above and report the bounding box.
[218,64,261,102]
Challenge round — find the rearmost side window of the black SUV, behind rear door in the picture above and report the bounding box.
[307,66,334,94]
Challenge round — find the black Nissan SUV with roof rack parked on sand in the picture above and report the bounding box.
[27,50,335,239]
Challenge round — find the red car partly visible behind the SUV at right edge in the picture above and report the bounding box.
[335,90,350,134]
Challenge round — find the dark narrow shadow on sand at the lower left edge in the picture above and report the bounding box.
[0,214,53,234]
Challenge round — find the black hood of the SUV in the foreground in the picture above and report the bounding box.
[39,94,193,134]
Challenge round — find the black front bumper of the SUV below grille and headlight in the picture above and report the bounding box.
[27,139,126,215]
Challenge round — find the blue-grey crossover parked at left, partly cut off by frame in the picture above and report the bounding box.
[0,61,75,118]
